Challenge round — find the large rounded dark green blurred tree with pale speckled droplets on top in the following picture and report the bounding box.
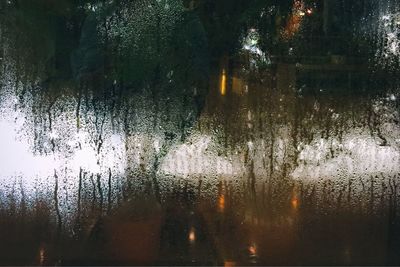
[72,0,208,97]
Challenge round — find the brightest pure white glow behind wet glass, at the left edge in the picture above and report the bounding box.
[0,93,126,204]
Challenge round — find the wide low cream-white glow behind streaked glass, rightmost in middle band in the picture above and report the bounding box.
[291,133,400,180]
